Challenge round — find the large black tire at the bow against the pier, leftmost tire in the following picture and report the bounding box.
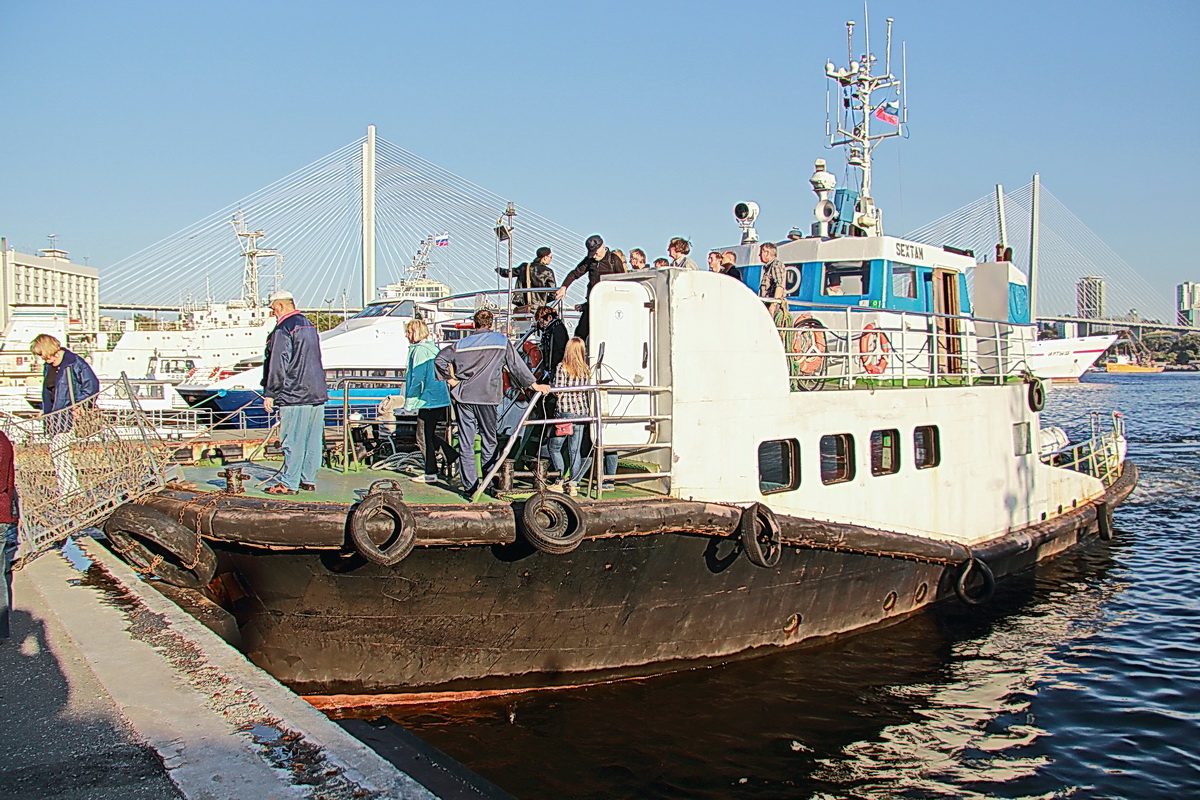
[104,505,217,589]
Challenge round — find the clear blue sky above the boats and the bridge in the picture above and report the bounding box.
[0,0,1200,291]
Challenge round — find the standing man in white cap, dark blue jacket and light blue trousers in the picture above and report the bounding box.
[263,291,329,494]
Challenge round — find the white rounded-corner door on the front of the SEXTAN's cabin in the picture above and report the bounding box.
[589,281,655,447]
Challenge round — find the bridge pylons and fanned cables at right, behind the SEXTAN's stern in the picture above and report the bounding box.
[906,181,1176,330]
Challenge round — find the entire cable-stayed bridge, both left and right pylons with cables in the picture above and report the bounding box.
[101,130,1171,330]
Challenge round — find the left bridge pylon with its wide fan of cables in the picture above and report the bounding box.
[101,131,584,309]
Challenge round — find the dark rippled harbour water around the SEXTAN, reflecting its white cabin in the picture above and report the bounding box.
[350,374,1200,800]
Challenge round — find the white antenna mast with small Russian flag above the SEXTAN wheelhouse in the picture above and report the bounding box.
[826,17,907,236]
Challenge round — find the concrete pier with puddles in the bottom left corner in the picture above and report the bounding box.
[0,540,508,800]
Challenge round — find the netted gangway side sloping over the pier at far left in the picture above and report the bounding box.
[0,377,170,561]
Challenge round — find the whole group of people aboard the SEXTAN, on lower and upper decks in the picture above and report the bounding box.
[250,235,787,497]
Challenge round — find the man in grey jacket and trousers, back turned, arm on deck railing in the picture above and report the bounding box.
[433,308,550,499]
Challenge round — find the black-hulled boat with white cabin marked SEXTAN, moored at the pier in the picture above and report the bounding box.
[106,14,1138,699]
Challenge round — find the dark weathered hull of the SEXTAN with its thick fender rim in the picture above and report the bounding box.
[138,462,1138,698]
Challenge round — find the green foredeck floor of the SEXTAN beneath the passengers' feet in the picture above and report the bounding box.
[175,462,661,505]
